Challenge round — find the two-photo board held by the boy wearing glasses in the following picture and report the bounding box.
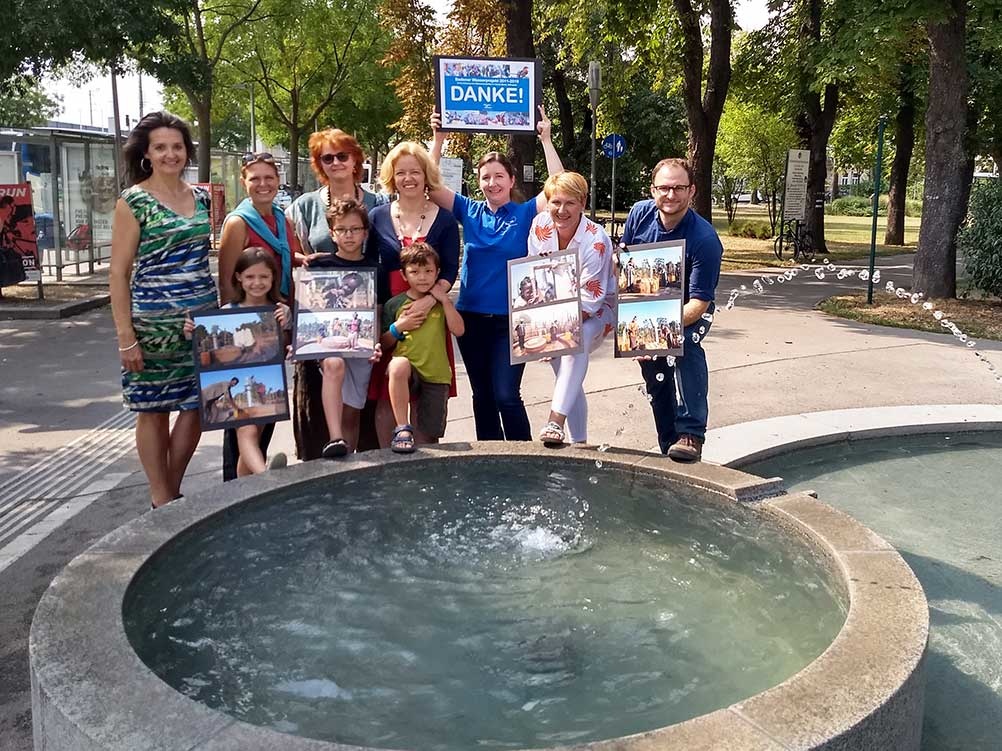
[293,266,382,359]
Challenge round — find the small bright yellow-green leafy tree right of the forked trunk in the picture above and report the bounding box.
[716,98,797,234]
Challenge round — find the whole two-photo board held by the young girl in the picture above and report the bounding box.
[191,306,290,431]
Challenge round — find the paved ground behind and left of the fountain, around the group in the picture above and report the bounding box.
[0,256,1002,751]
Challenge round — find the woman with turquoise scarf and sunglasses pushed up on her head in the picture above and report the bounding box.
[219,153,303,481]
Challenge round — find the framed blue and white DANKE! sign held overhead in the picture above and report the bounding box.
[433,55,542,133]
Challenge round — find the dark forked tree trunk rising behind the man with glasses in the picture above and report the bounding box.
[674,0,733,221]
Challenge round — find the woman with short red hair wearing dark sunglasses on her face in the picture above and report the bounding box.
[289,128,387,462]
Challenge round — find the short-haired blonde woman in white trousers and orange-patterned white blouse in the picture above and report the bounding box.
[529,172,616,446]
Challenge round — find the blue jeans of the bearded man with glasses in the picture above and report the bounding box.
[640,303,713,454]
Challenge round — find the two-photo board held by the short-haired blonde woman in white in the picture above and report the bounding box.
[508,250,582,365]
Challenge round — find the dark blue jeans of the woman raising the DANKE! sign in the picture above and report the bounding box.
[458,310,531,441]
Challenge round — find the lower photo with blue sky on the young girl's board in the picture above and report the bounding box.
[198,362,289,431]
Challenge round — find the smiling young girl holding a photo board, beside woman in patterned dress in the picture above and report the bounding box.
[184,247,293,477]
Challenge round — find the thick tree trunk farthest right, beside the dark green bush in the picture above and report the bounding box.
[912,0,970,298]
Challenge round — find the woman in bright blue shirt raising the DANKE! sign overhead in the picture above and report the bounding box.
[429,107,563,441]
